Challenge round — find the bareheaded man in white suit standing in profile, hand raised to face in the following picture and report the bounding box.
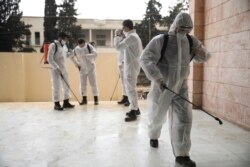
[114,19,142,122]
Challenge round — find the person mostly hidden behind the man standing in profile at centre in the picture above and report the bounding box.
[114,29,129,106]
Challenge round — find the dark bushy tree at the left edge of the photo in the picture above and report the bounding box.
[0,0,31,52]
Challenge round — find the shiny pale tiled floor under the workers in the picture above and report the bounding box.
[0,101,250,167]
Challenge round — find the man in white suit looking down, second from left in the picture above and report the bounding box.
[71,39,99,105]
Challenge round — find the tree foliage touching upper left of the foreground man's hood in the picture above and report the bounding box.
[161,0,189,28]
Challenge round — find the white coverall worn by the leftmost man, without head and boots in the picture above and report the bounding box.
[48,40,70,102]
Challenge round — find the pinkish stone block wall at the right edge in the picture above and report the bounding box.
[190,0,250,128]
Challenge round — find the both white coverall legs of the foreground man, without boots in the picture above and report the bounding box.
[148,82,192,156]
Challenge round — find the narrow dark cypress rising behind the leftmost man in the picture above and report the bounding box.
[43,0,57,42]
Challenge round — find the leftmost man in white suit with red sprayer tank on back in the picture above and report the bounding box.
[48,32,74,110]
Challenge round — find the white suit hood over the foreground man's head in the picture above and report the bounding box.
[169,12,193,34]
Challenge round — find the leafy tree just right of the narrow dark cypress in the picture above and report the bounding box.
[58,0,82,48]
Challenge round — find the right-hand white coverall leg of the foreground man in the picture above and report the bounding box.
[169,81,192,156]
